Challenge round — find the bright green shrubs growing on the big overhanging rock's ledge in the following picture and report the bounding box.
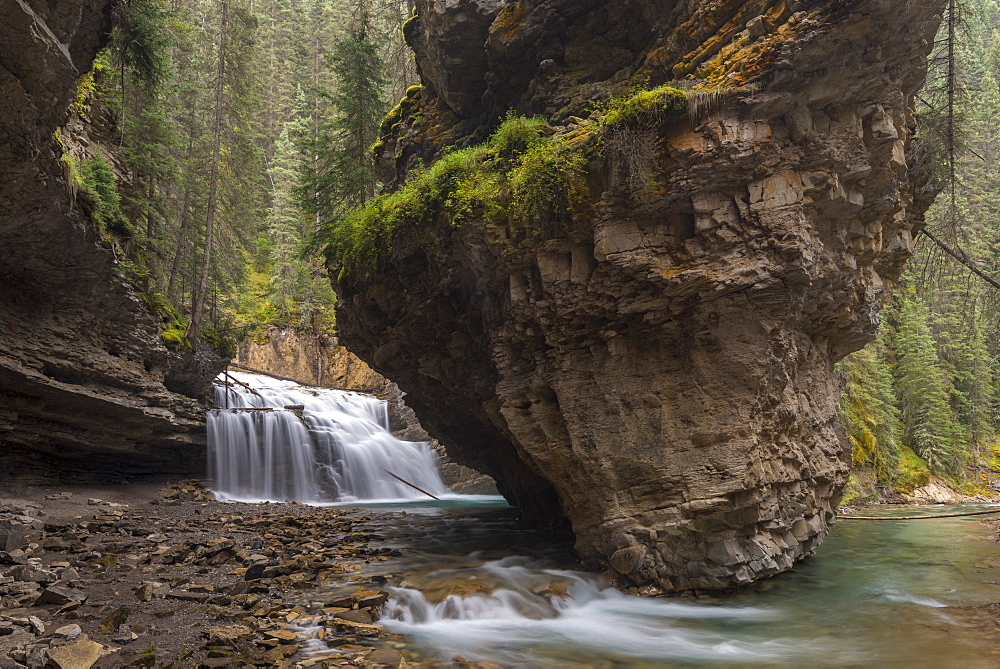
[326,116,585,282]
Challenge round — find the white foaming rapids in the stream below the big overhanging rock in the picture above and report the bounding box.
[380,558,836,666]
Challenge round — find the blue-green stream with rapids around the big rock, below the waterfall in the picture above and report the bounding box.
[303,497,1000,667]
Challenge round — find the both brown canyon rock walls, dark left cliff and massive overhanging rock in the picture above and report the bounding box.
[0,0,943,592]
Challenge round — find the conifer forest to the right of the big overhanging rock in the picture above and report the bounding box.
[839,0,1000,500]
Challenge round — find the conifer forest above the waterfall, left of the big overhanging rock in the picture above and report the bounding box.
[63,0,416,350]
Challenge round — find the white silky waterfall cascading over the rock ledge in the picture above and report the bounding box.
[208,372,449,504]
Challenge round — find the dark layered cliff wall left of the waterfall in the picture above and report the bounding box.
[0,0,224,476]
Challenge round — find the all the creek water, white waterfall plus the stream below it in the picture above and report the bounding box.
[208,374,1000,667]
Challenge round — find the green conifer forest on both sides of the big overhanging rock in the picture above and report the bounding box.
[63,0,1000,500]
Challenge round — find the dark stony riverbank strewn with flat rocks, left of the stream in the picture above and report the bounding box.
[0,482,484,669]
